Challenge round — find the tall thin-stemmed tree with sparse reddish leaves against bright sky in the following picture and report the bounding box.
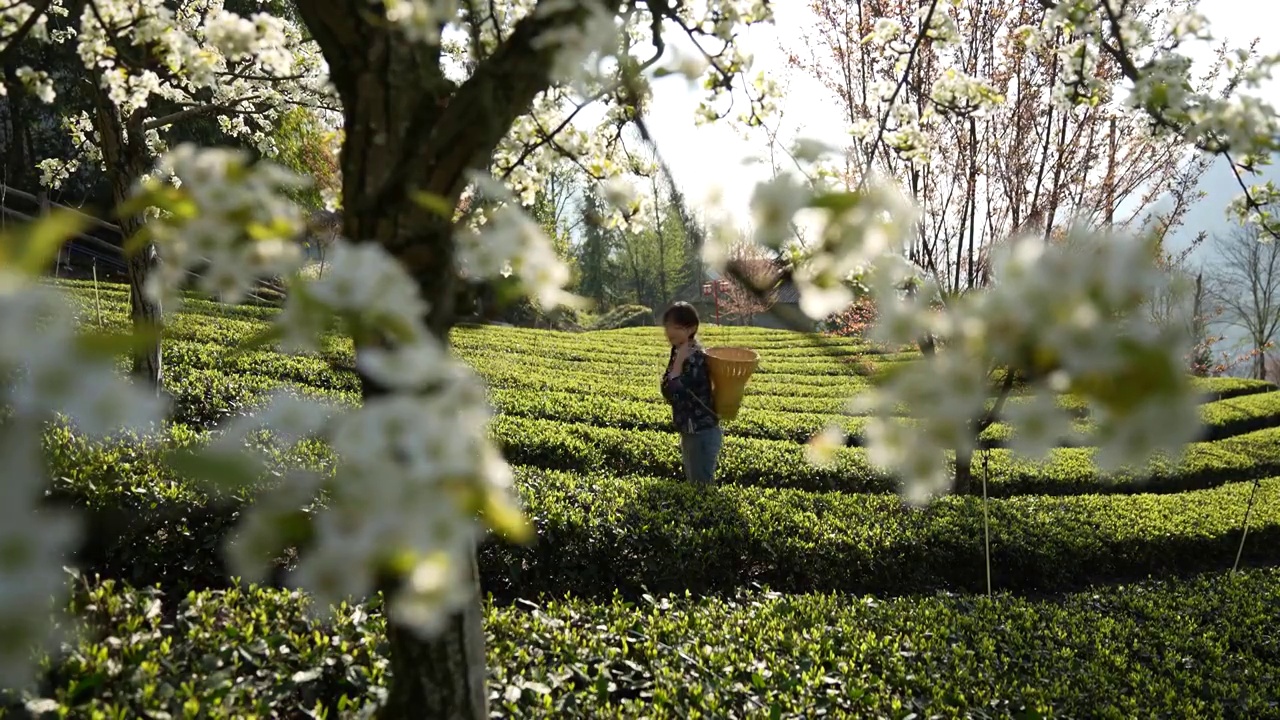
[790,0,1213,293]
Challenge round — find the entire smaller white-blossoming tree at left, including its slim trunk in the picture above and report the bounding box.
[12,0,337,388]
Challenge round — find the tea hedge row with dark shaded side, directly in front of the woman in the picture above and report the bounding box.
[47,427,1280,598]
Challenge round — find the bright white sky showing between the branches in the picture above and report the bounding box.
[648,0,1280,257]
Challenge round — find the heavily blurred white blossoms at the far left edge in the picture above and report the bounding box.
[0,269,164,688]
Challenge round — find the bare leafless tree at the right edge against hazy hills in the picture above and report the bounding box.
[1204,213,1280,380]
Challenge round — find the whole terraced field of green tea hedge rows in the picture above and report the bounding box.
[17,278,1280,719]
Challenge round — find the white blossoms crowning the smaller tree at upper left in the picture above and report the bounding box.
[26,0,335,187]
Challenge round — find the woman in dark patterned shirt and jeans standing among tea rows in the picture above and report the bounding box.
[662,302,724,484]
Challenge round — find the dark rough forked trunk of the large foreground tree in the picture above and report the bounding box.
[298,0,617,720]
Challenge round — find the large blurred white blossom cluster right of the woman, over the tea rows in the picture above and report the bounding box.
[856,228,1199,497]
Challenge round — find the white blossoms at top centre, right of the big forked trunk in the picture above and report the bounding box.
[478,0,778,229]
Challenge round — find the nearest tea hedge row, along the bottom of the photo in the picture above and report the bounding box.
[17,570,1280,720]
